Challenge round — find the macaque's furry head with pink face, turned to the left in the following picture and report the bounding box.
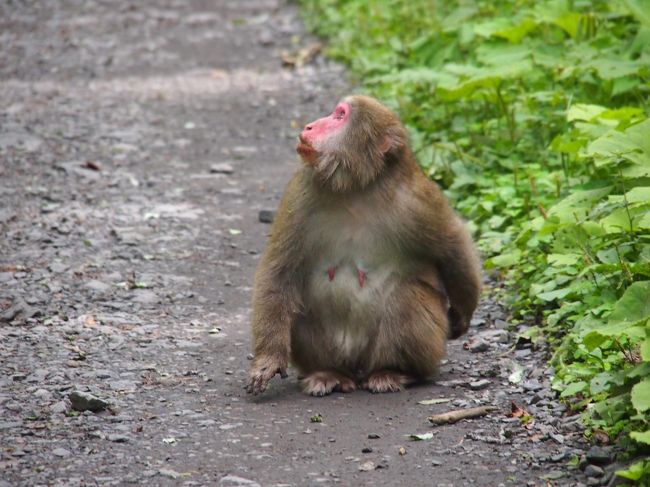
[296,95,406,192]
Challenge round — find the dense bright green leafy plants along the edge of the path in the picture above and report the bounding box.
[300,0,650,485]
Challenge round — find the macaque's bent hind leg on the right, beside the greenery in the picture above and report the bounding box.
[362,282,449,392]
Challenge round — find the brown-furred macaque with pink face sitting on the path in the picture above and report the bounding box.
[246,96,481,396]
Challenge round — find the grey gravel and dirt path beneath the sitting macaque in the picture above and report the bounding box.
[0,0,610,487]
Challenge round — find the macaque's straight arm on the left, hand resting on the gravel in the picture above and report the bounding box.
[246,175,302,394]
